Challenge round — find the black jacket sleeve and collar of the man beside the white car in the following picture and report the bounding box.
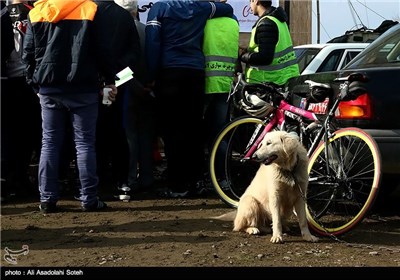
[241,7,288,65]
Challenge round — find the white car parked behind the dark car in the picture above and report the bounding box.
[294,43,369,75]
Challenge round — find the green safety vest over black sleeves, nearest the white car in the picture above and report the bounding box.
[246,16,300,85]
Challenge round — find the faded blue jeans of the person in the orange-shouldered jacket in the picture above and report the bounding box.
[38,92,99,206]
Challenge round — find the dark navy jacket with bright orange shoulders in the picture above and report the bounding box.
[22,0,116,93]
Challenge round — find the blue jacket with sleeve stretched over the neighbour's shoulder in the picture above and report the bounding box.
[146,0,233,81]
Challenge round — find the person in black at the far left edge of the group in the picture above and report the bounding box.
[1,0,41,201]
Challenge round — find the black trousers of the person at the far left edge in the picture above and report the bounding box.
[1,77,42,195]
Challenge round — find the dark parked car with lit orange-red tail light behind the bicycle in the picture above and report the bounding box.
[288,24,400,192]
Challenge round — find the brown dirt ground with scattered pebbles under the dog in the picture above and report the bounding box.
[1,176,400,271]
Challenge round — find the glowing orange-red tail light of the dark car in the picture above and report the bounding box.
[335,93,372,119]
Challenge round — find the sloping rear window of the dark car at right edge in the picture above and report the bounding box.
[344,25,400,69]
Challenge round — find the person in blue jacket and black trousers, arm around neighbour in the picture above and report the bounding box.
[146,0,233,197]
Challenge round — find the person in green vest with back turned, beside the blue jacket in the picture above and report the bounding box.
[203,17,241,184]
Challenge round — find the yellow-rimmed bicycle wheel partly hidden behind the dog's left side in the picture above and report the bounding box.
[209,116,264,208]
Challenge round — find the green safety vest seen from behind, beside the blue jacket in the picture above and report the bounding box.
[203,17,239,93]
